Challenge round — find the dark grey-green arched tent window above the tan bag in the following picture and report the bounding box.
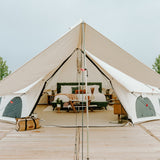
[3,97,22,118]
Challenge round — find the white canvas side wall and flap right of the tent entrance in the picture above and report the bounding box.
[87,52,160,123]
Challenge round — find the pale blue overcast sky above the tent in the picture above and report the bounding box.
[0,0,160,71]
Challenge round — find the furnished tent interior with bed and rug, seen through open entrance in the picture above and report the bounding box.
[34,49,127,126]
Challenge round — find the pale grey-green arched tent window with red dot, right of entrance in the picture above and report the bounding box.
[136,96,156,118]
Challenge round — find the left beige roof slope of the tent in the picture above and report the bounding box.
[0,25,80,96]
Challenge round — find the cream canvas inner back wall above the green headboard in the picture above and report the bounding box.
[45,52,111,93]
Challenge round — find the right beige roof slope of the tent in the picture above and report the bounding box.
[85,24,160,88]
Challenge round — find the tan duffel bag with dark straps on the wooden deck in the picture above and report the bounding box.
[16,117,41,131]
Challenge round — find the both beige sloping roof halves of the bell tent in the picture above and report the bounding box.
[0,23,160,95]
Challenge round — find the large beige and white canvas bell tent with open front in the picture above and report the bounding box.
[0,22,160,123]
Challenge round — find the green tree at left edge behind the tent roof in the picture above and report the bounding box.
[0,57,11,80]
